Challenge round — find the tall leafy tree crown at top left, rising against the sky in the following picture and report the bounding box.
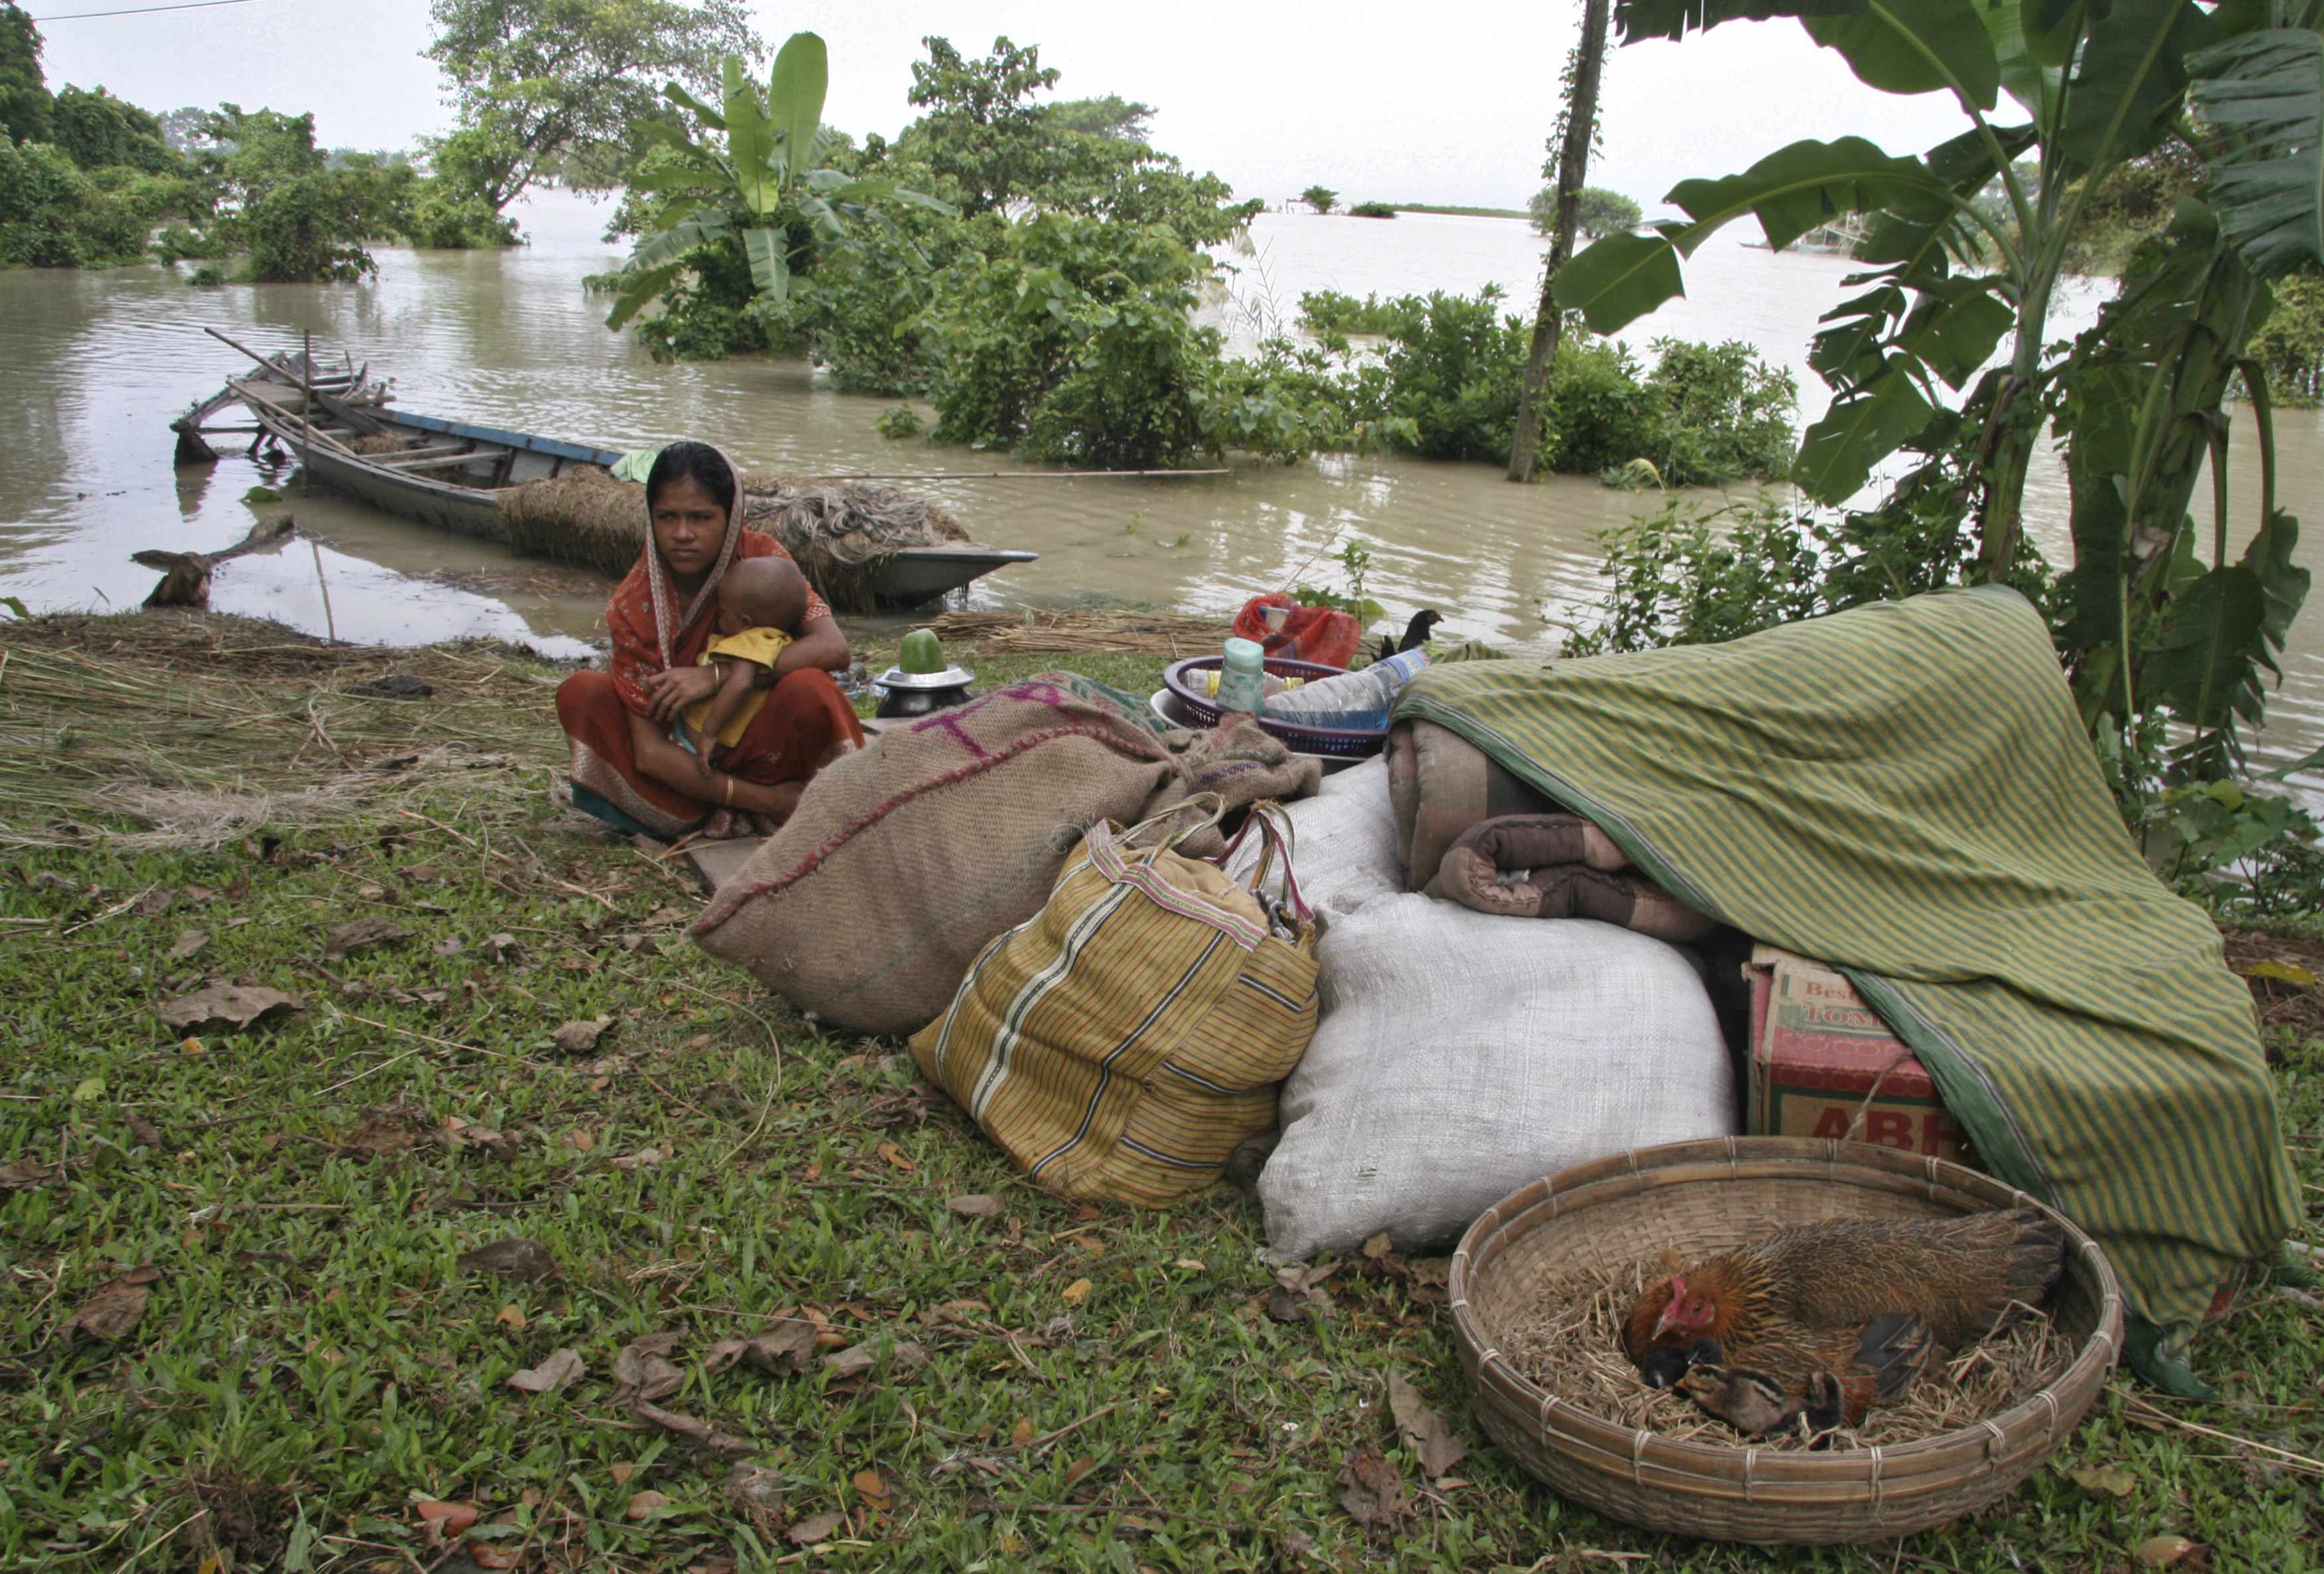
[426,0,762,214]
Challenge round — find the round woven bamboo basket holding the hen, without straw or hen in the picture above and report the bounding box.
[1450,1137,2122,1543]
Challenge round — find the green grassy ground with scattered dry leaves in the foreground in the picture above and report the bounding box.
[0,616,2324,1574]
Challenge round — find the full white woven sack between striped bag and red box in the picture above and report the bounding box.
[1260,883,1736,1263]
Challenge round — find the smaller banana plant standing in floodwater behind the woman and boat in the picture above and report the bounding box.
[604,33,953,328]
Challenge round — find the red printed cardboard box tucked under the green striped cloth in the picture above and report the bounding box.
[1748,946,1978,1165]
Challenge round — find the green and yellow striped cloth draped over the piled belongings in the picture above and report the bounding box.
[1394,588,2299,1390]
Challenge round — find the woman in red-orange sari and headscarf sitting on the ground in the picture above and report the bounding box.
[558,442,865,841]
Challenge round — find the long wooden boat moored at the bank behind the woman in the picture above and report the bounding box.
[172,347,1039,607]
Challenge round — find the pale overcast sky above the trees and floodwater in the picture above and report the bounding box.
[26,0,1961,212]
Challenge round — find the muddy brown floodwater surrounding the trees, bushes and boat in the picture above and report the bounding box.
[0,193,2324,781]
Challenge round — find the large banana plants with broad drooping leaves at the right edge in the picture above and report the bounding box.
[1557,0,2324,774]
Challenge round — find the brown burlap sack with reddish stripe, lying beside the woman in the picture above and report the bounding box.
[693,672,1320,1032]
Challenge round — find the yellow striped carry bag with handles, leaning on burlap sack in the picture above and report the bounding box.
[911,798,1315,1207]
